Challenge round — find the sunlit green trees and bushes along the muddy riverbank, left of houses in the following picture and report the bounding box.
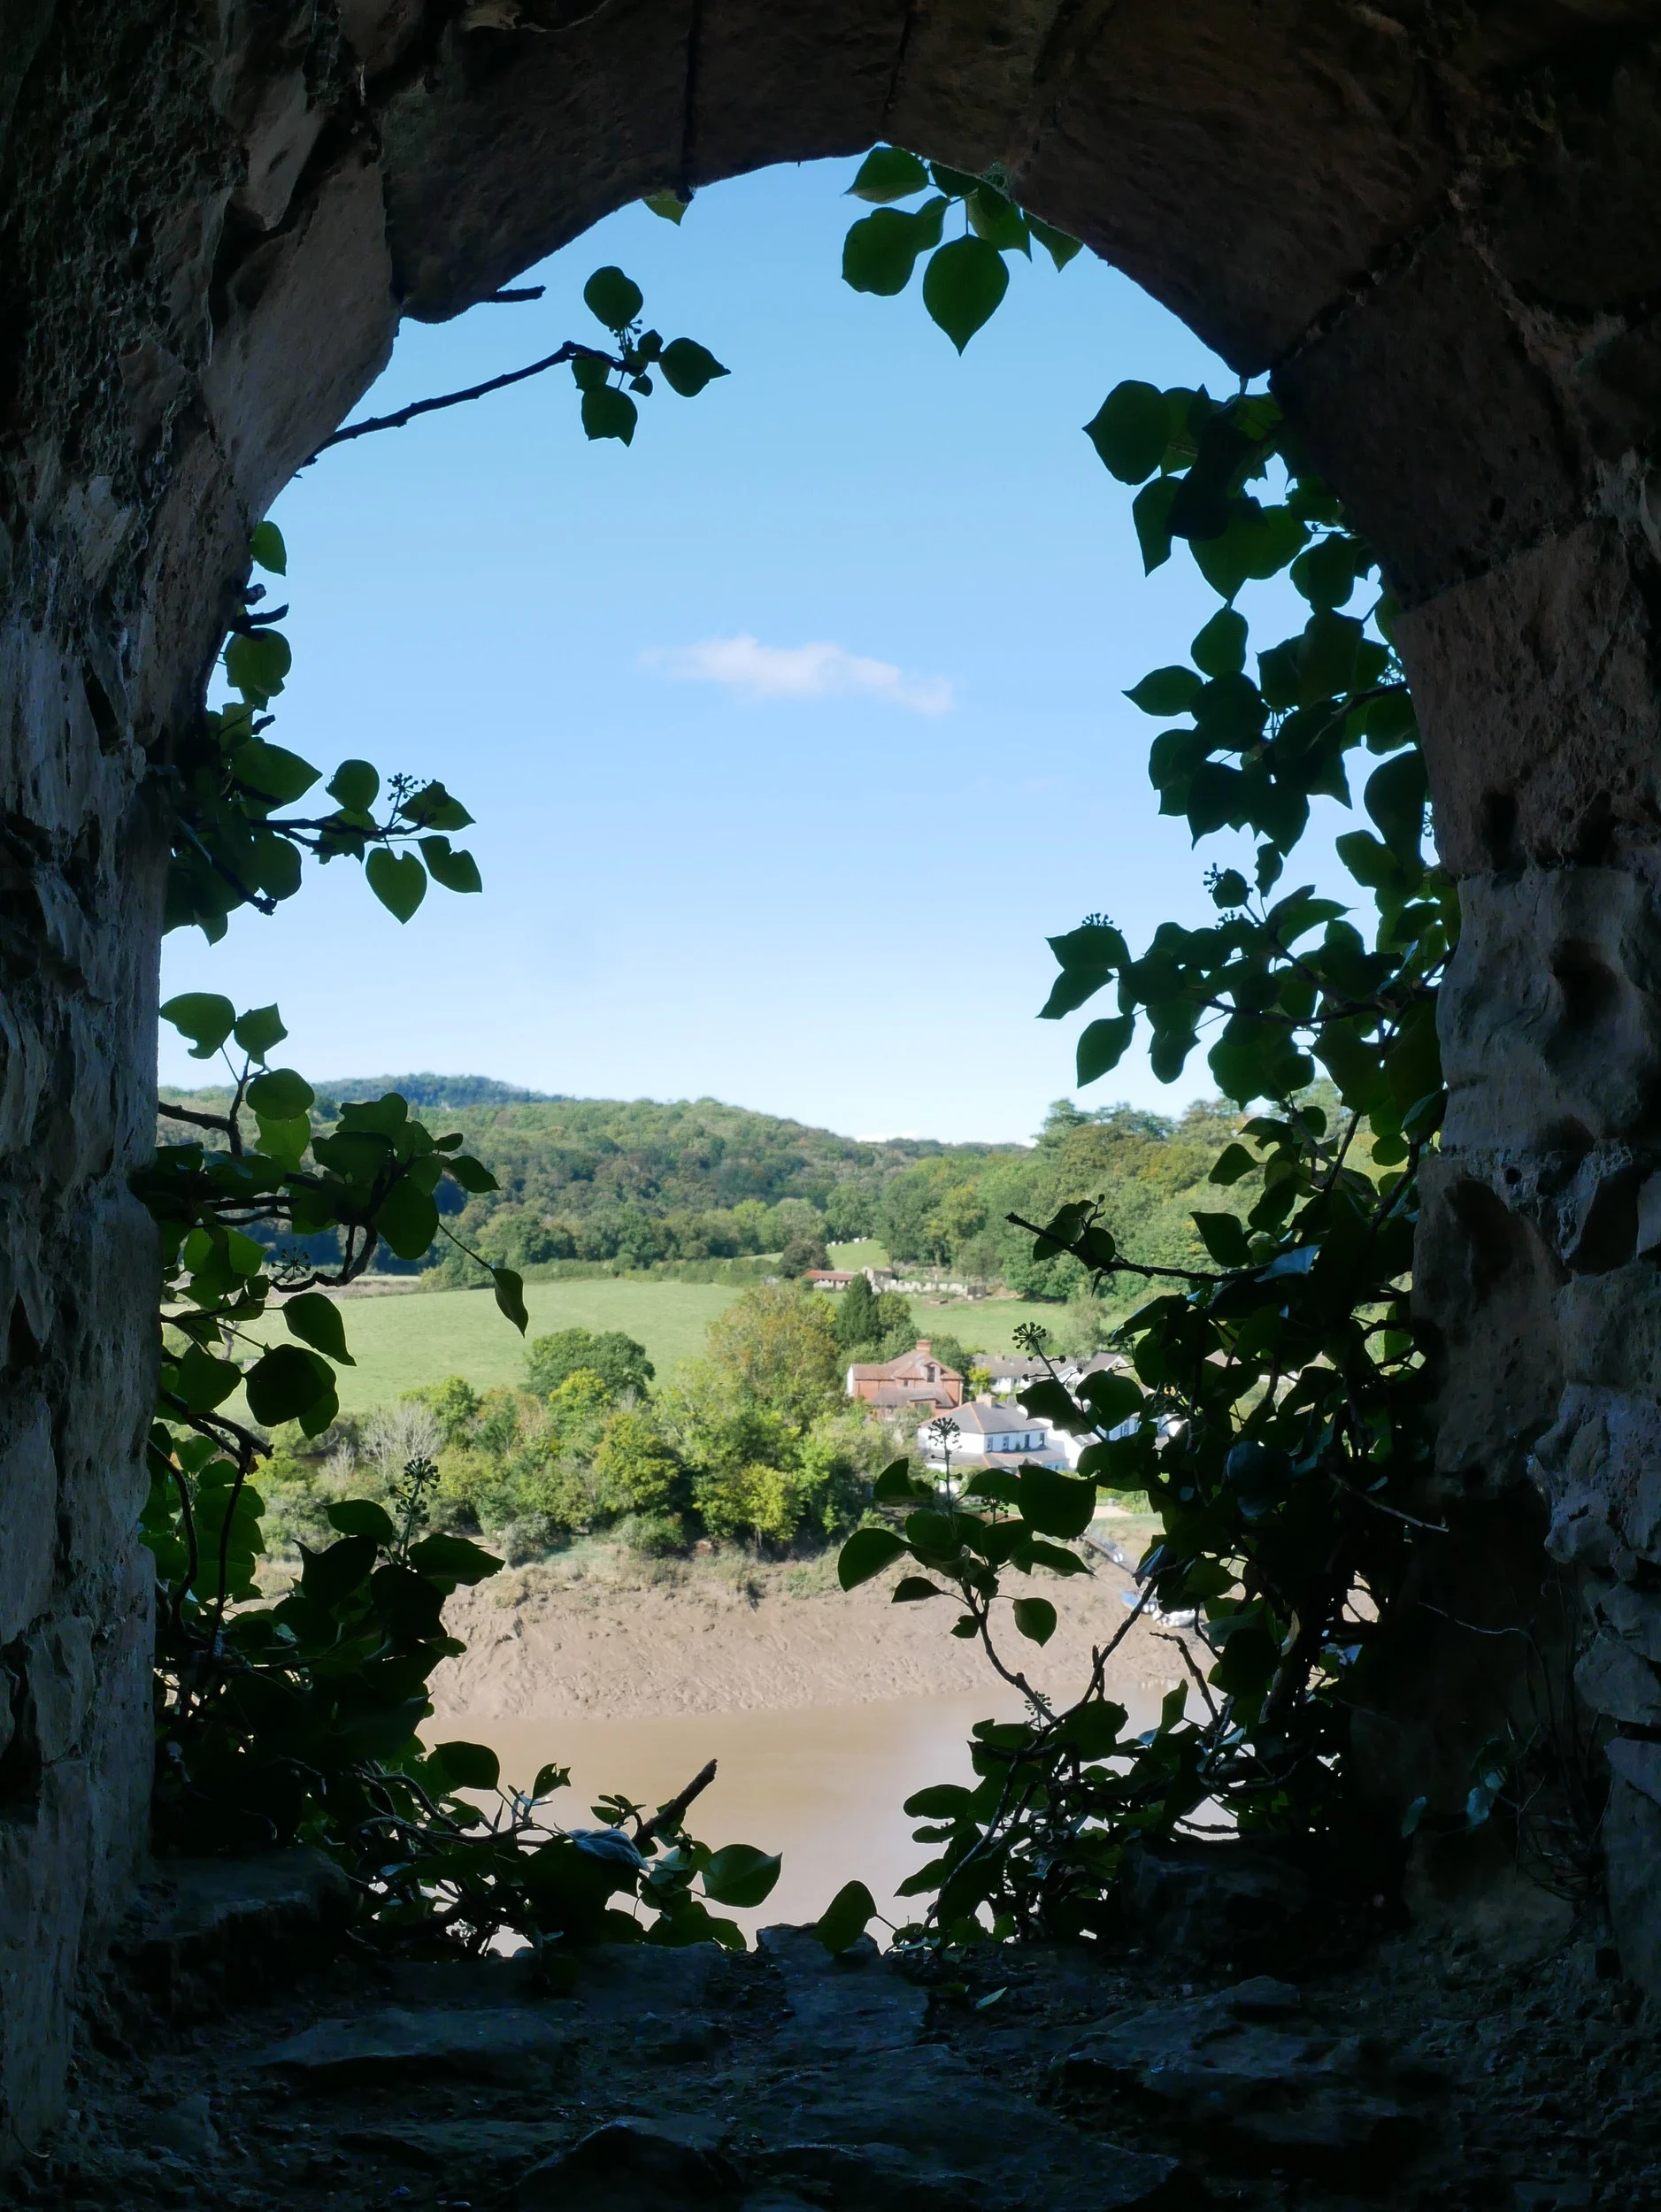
[261,1283,916,1562]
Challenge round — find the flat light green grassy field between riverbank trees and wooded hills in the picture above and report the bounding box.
[261,1277,1057,1414]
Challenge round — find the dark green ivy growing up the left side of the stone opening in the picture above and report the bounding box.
[135,268,779,1969]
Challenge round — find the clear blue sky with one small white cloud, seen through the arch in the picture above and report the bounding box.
[161,164,1326,1140]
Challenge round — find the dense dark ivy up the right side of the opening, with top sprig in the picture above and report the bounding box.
[825,149,1459,1949]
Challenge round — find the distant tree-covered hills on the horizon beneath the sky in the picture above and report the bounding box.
[156,1075,1241,1299]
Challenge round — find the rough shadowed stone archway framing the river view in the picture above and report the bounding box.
[0,0,1661,2139]
